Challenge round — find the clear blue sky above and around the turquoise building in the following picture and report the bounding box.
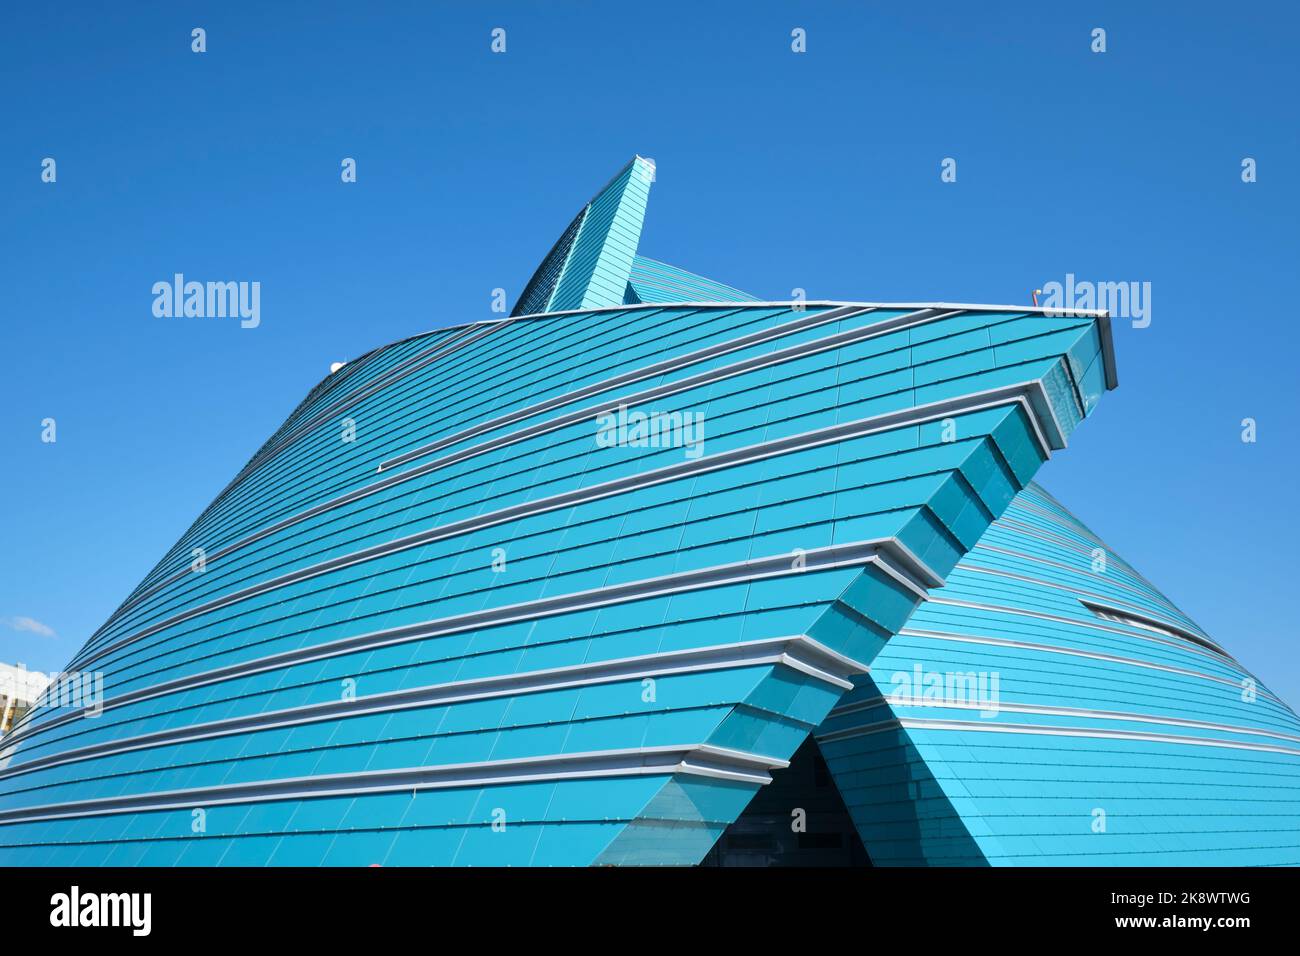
[0,1,1300,705]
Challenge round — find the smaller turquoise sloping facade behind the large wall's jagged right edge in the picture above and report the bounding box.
[816,484,1300,866]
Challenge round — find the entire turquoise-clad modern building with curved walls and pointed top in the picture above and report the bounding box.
[0,157,1300,866]
